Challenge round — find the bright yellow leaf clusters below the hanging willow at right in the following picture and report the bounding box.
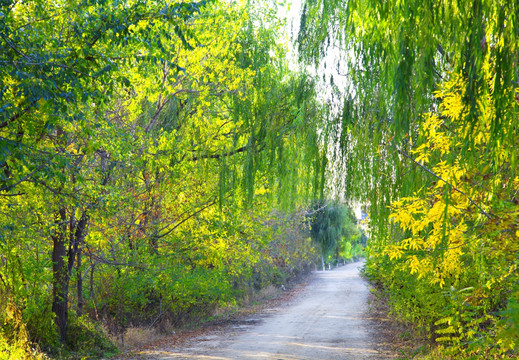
[382,69,519,288]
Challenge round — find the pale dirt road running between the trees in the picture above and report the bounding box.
[136,263,392,360]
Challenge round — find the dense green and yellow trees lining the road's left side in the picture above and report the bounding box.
[0,0,354,358]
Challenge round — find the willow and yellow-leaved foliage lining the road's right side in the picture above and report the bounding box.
[298,0,519,357]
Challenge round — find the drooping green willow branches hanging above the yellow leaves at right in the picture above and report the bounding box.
[298,0,519,233]
